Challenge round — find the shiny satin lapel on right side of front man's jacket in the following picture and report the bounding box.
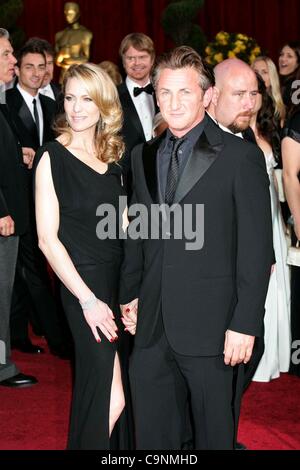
[174,116,223,203]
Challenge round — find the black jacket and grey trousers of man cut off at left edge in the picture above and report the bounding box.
[0,105,28,381]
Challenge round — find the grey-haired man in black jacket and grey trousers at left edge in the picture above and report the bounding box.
[0,28,37,387]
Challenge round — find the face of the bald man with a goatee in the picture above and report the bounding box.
[215,70,258,134]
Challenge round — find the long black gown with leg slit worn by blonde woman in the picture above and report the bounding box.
[35,141,128,450]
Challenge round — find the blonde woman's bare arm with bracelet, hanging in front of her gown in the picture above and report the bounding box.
[35,152,117,342]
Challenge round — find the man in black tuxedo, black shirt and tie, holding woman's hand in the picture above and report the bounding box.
[120,46,272,449]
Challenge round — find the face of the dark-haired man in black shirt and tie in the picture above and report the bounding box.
[156,67,211,137]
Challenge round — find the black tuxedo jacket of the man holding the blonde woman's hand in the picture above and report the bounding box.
[120,118,272,356]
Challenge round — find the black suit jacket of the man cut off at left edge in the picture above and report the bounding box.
[0,105,28,235]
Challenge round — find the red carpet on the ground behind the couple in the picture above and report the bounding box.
[0,336,300,450]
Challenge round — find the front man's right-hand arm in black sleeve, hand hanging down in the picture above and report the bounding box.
[224,146,273,365]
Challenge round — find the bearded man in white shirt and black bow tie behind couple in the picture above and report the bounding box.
[118,33,157,193]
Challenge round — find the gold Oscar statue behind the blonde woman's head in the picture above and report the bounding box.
[55,2,93,82]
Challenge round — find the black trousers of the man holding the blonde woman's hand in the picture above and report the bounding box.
[129,326,235,450]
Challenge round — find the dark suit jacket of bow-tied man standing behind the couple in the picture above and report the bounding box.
[118,82,157,194]
